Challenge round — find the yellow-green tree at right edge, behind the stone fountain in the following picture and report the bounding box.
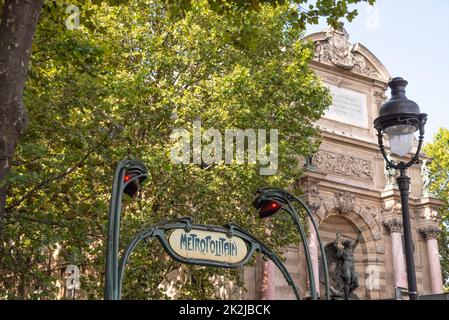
[424,128,449,289]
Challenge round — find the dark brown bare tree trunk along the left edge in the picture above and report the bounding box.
[0,0,44,224]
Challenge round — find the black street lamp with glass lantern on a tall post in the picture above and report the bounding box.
[374,78,427,300]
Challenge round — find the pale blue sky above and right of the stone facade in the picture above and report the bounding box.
[307,0,449,143]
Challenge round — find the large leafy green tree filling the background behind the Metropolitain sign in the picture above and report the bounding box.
[0,0,374,298]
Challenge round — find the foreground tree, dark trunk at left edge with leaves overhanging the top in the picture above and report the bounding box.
[0,0,375,220]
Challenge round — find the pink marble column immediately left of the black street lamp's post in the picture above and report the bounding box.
[384,217,408,288]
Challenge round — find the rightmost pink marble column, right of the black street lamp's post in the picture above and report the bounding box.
[420,225,443,294]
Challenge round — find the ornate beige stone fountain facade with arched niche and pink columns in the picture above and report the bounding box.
[243,29,443,299]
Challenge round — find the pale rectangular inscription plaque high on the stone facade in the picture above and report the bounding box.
[324,83,368,128]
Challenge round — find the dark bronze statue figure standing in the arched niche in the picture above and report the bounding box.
[320,232,362,300]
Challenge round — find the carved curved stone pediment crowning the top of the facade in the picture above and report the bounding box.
[305,27,390,82]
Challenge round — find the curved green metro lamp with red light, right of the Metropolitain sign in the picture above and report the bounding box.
[253,188,330,300]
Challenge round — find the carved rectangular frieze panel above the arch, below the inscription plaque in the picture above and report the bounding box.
[313,150,373,181]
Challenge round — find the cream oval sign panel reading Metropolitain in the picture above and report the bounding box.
[169,229,248,264]
